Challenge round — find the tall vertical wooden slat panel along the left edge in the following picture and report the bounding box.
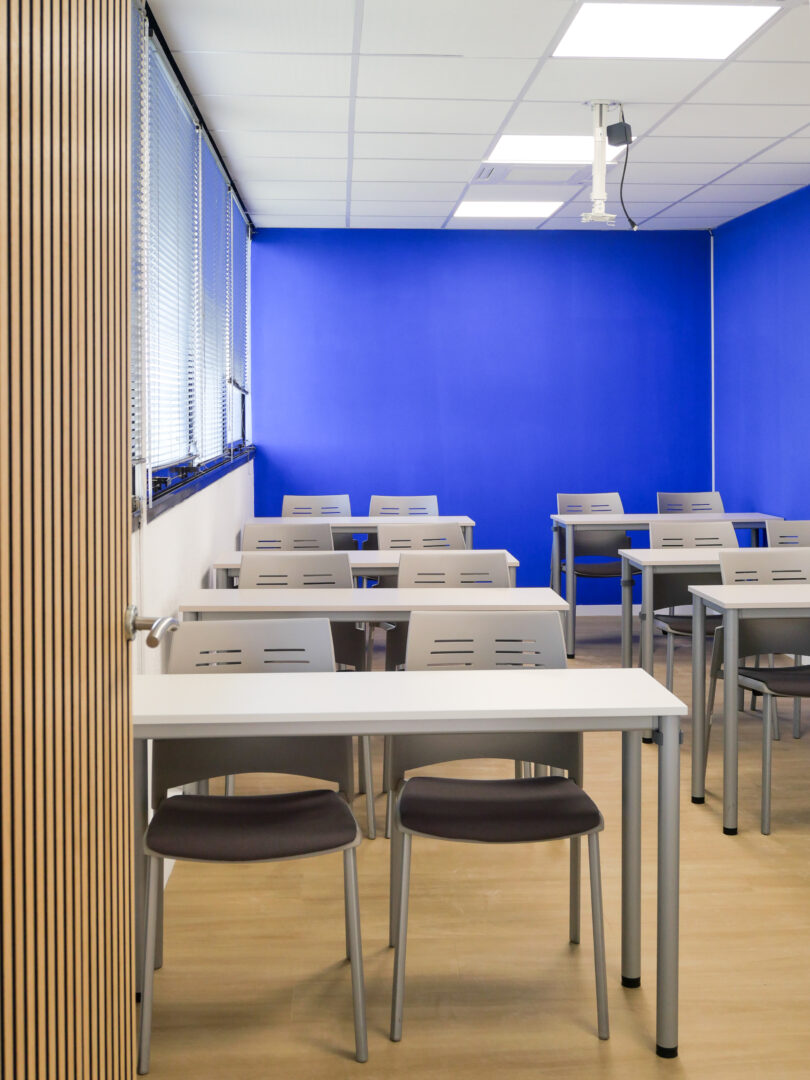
[0,0,134,1080]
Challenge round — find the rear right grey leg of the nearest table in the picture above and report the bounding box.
[622,731,642,986]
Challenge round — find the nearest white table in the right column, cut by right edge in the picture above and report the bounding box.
[689,584,810,836]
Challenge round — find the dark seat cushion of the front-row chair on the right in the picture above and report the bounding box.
[400,777,600,843]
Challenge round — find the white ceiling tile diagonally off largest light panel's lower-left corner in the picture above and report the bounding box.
[357,56,535,103]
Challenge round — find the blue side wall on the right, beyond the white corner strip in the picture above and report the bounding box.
[715,188,810,518]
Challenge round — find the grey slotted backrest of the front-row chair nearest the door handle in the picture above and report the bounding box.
[162,619,354,806]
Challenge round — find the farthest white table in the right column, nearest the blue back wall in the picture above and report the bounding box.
[551,511,781,657]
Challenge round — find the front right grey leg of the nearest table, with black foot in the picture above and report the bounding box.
[656,716,680,1057]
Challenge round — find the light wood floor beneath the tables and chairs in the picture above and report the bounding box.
[145,618,810,1080]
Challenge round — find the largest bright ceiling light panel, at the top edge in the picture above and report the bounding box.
[554,3,780,60]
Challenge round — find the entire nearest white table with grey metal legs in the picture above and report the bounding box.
[133,665,686,1057]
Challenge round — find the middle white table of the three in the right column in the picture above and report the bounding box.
[619,548,723,675]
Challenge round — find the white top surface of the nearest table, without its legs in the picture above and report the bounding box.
[133,665,687,739]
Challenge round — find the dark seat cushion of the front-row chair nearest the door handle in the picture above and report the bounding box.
[146,791,357,863]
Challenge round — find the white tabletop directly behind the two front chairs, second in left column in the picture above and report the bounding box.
[179,588,568,618]
